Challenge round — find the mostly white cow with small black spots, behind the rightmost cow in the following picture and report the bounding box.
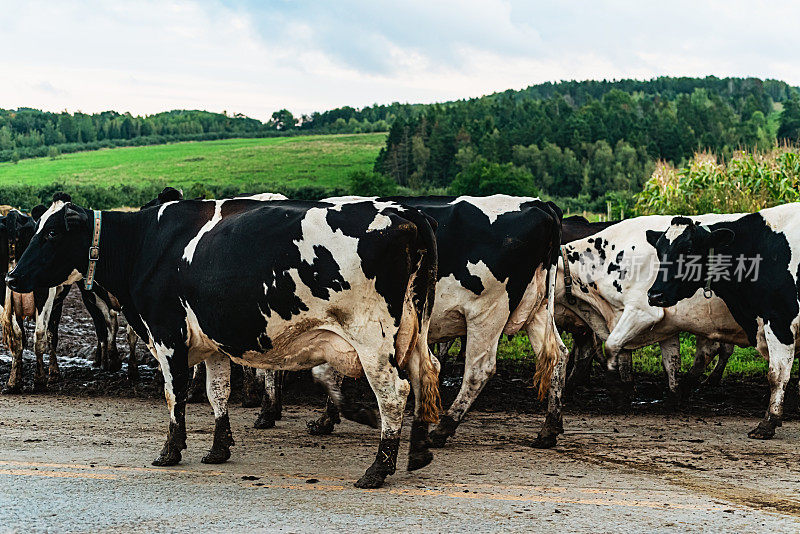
[556,214,747,406]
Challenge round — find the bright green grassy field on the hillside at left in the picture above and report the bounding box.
[0,133,386,191]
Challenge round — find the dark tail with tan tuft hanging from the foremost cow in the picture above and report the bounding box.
[403,210,442,423]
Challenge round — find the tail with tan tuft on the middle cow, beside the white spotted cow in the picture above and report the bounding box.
[533,202,563,400]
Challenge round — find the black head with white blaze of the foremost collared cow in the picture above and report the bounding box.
[6,200,92,293]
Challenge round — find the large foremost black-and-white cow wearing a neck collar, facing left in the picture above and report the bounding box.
[7,199,439,487]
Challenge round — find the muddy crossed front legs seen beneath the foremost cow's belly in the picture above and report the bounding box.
[306,364,378,436]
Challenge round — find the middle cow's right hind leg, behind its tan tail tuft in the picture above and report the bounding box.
[525,308,569,449]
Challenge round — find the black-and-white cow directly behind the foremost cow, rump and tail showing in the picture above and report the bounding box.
[290,195,566,447]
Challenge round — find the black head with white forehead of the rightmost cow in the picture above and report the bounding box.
[647,217,734,308]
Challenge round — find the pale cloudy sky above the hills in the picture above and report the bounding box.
[0,0,800,120]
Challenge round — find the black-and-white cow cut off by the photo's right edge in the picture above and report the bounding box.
[647,204,800,439]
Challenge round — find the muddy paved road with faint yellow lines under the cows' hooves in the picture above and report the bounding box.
[0,396,800,532]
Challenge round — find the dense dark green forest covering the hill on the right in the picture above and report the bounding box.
[375,77,800,209]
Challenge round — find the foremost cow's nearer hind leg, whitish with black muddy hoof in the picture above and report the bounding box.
[355,353,411,488]
